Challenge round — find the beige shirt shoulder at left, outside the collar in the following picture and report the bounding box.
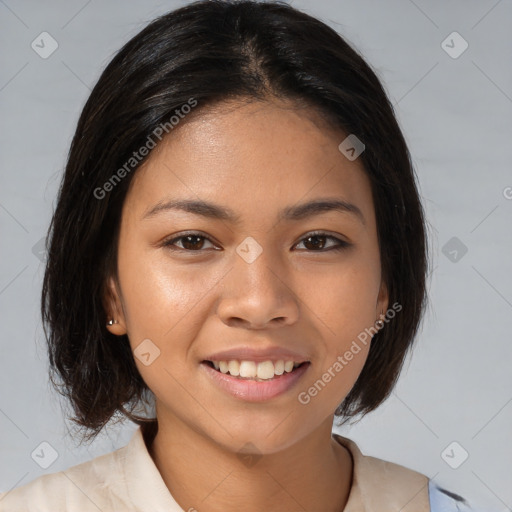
[0,446,129,512]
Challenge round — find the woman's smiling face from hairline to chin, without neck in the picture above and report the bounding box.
[109,98,388,453]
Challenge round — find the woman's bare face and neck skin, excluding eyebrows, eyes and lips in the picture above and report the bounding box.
[108,100,388,512]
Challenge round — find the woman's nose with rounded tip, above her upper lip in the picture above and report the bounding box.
[217,246,300,329]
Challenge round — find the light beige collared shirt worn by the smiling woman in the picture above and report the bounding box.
[0,427,430,512]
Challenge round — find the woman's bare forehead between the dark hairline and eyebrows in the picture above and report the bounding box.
[122,101,373,228]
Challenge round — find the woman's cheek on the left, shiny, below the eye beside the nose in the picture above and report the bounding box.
[119,246,227,401]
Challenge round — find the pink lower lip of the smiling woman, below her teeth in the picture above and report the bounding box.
[200,363,310,402]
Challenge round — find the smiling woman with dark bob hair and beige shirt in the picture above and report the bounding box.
[0,1,472,512]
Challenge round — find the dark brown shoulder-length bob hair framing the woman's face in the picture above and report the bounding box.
[41,0,428,439]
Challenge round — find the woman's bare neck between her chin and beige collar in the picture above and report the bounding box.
[145,417,353,512]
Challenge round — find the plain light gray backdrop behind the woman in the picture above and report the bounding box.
[0,0,512,511]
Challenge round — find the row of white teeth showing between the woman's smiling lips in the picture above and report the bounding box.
[201,360,311,382]
